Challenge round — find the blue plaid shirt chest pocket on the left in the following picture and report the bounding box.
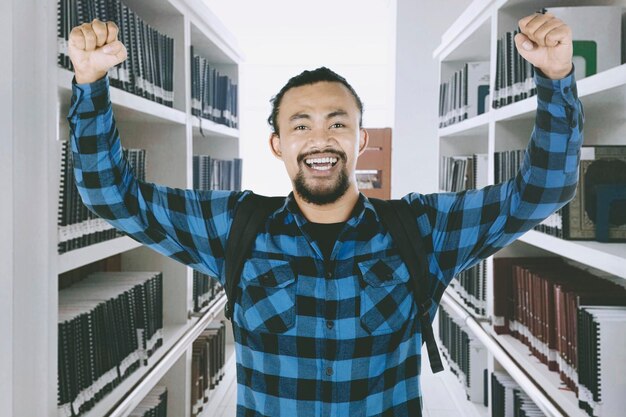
[235,258,296,333]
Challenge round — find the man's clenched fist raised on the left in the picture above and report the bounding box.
[68,19,126,84]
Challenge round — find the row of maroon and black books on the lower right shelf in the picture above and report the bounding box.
[493,258,626,416]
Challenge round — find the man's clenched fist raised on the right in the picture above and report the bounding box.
[515,13,573,80]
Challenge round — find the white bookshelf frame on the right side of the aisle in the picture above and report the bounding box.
[433,0,626,417]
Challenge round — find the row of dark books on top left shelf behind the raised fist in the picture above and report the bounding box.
[57,0,174,107]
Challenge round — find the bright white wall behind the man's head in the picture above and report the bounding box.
[205,0,396,195]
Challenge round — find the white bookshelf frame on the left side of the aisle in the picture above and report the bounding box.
[5,0,242,417]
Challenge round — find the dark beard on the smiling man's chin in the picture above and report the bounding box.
[293,153,350,206]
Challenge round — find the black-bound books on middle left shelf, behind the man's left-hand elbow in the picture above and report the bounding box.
[57,141,146,253]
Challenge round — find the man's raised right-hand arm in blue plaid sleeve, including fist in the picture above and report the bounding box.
[405,14,584,285]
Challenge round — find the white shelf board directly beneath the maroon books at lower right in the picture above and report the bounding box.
[483,325,589,417]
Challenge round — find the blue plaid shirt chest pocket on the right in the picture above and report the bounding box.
[358,255,413,335]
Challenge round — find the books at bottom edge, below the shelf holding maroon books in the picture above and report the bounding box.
[491,371,545,417]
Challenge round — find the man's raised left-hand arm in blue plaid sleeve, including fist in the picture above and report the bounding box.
[68,20,243,281]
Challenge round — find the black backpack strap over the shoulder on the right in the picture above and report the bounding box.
[369,198,443,373]
